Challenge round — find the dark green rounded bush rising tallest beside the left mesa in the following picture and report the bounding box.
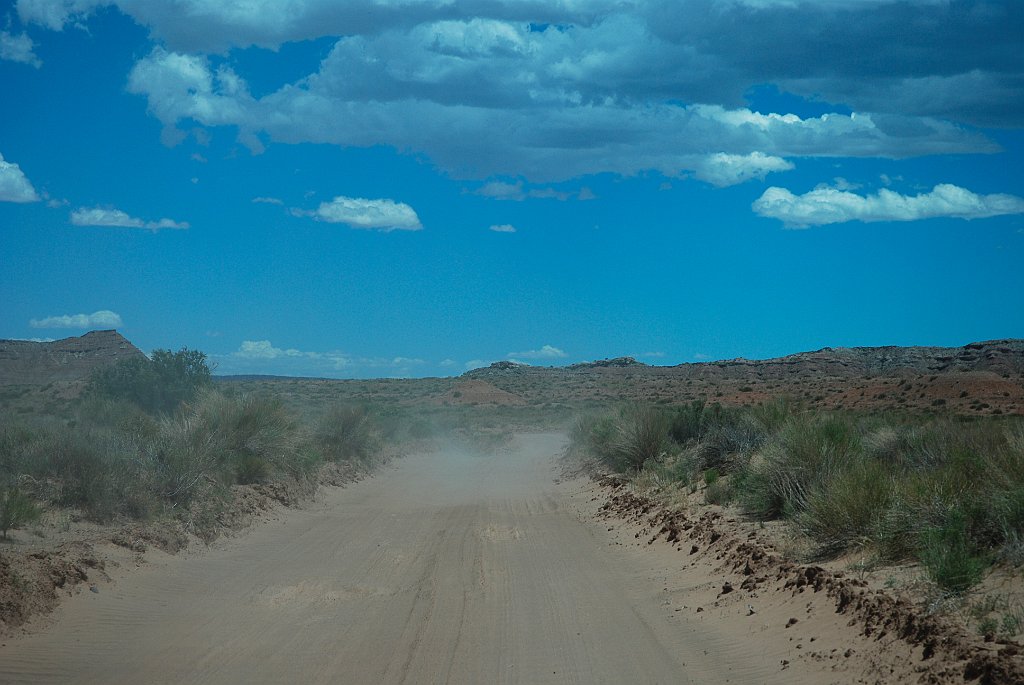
[88,347,211,414]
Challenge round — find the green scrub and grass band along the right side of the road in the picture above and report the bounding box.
[571,399,1024,594]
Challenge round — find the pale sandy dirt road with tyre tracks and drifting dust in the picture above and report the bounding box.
[0,434,793,684]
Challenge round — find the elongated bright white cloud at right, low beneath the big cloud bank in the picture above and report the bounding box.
[753,183,1024,228]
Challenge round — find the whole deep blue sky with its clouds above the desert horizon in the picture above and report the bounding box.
[0,0,1024,378]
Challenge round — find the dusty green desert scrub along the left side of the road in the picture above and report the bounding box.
[0,350,393,537]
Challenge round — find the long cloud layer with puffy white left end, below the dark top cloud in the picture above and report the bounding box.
[119,35,997,184]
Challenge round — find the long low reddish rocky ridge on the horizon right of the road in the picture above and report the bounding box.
[461,339,1024,416]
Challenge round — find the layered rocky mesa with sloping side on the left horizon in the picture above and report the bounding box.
[0,331,145,385]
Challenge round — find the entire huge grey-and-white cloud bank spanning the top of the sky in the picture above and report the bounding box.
[18,0,1024,184]
